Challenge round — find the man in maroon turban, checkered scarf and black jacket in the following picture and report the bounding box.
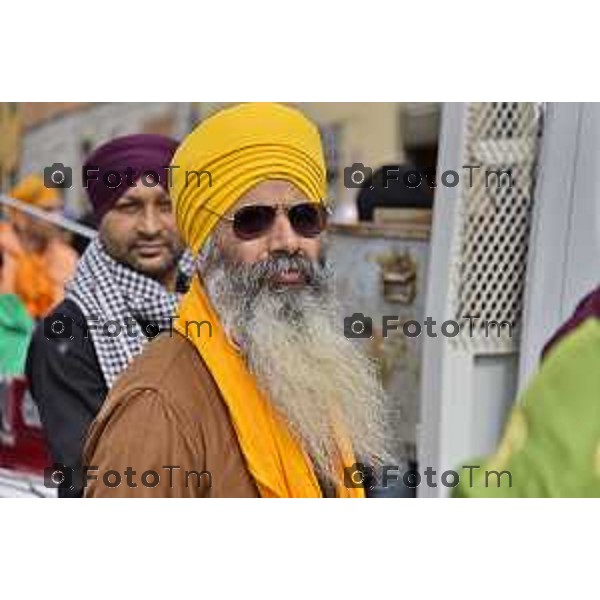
[26,134,192,496]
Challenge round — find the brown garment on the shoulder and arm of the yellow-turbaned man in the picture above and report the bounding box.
[83,333,259,498]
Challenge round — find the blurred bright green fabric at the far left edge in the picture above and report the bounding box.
[0,294,33,376]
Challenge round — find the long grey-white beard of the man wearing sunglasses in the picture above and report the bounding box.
[203,241,391,485]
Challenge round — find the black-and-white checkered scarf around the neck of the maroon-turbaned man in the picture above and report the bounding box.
[65,239,193,389]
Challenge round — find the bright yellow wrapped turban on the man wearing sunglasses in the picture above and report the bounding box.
[171,102,326,252]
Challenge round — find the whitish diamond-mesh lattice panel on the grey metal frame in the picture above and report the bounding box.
[451,102,541,354]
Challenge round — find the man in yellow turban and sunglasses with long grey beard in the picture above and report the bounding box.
[84,103,387,497]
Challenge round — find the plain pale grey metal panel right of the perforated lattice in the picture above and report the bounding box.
[519,102,600,388]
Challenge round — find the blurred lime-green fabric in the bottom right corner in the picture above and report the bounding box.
[453,318,600,498]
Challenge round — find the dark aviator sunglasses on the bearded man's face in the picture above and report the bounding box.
[222,202,329,240]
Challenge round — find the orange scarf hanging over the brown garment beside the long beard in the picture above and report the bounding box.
[175,277,364,498]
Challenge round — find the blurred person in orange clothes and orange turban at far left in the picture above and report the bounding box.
[0,175,78,318]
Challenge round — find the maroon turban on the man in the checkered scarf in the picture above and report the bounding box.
[82,133,178,223]
